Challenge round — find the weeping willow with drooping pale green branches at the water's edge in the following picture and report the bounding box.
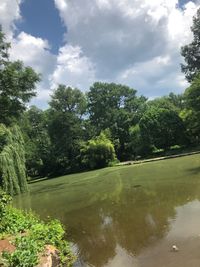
[0,124,28,195]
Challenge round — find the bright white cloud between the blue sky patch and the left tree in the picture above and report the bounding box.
[10,32,56,107]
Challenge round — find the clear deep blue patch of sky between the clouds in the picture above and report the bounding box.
[17,0,65,53]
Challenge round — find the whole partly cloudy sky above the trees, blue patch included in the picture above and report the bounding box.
[0,0,200,108]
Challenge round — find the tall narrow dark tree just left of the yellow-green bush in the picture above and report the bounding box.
[48,85,86,175]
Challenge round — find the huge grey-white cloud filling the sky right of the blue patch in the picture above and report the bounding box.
[54,0,198,96]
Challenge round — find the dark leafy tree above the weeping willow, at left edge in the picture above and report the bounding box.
[0,29,40,125]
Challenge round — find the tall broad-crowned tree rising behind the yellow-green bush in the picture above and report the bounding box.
[87,82,146,160]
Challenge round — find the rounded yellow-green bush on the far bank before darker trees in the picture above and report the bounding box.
[81,133,116,169]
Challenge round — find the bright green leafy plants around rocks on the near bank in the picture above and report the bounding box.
[0,195,74,267]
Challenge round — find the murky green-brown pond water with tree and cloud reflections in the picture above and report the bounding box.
[15,155,200,267]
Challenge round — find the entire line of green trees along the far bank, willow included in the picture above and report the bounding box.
[0,6,200,193]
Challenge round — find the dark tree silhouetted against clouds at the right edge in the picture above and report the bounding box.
[181,9,200,82]
